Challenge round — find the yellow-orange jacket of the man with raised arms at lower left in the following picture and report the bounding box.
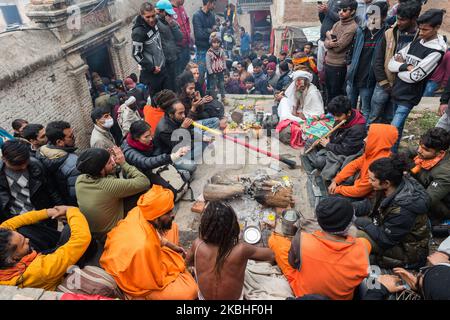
[0,208,91,291]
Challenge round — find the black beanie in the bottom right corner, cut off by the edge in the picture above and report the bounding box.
[423,264,450,300]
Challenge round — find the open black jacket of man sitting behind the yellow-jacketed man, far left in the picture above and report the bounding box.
[0,158,65,221]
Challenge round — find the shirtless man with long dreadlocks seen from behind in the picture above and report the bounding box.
[187,202,274,300]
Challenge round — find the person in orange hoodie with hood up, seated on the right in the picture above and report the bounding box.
[328,123,398,200]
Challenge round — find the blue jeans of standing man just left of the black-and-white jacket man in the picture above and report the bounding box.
[367,84,394,125]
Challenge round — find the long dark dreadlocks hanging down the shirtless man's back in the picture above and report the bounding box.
[199,201,240,276]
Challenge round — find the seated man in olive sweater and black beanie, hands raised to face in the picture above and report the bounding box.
[75,147,150,242]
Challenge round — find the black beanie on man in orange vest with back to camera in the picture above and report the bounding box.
[316,196,354,233]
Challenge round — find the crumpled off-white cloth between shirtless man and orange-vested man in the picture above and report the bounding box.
[244,260,294,300]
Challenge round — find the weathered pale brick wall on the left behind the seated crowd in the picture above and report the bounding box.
[0,59,92,147]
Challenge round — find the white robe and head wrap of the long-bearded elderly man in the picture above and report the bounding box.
[278,71,325,122]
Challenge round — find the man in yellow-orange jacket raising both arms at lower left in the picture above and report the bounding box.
[0,206,91,291]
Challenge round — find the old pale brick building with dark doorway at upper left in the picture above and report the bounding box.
[0,0,142,147]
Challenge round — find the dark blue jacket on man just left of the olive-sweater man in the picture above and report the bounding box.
[36,143,80,206]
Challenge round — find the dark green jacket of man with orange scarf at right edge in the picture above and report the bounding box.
[415,152,450,216]
